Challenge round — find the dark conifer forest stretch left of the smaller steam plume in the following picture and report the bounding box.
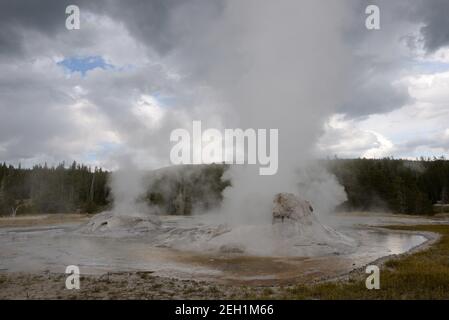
[0,162,109,215]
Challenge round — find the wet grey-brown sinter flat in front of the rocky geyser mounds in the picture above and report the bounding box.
[0,212,440,284]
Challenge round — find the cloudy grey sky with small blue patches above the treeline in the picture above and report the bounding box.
[0,0,449,169]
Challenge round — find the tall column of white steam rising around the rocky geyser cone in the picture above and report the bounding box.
[199,1,347,223]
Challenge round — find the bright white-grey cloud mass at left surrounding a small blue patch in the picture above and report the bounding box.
[0,0,206,167]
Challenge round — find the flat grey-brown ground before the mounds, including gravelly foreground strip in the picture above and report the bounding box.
[0,213,448,299]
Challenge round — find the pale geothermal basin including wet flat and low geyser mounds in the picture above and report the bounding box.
[0,213,441,285]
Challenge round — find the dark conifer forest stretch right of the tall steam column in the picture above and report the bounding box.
[327,159,449,214]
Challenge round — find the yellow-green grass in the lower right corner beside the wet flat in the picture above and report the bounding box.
[280,225,449,299]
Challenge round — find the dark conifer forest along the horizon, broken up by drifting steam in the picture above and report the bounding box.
[0,159,449,215]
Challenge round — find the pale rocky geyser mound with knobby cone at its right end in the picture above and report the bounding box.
[80,188,355,256]
